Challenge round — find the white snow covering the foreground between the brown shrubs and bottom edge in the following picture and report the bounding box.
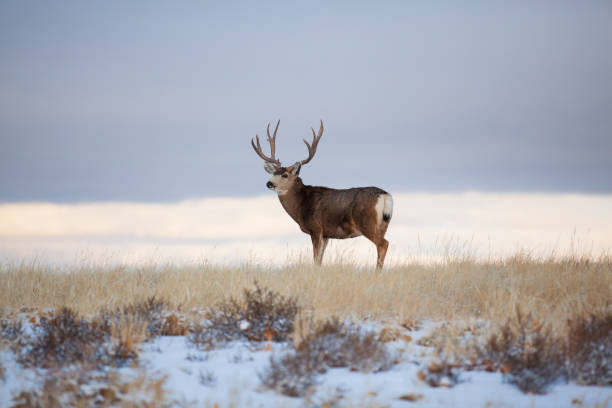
[0,324,612,407]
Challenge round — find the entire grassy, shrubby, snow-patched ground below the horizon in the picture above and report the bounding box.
[0,252,612,407]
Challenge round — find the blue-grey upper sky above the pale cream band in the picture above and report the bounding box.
[0,0,612,204]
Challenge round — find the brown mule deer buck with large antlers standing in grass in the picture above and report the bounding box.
[251,120,393,269]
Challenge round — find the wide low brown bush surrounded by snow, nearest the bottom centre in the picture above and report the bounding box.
[260,319,393,397]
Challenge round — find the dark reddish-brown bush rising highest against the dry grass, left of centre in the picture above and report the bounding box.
[188,282,299,349]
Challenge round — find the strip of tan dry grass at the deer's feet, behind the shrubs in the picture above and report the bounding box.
[0,253,612,323]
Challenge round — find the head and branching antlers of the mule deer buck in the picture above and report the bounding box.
[251,120,323,195]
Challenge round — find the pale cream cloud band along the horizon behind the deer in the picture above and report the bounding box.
[0,193,612,266]
